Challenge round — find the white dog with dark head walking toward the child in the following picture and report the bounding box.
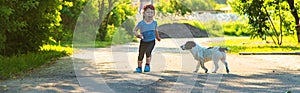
[180,41,229,73]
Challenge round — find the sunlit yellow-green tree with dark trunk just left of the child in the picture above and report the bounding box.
[98,0,137,41]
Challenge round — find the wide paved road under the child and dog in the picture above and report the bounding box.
[0,38,300,93]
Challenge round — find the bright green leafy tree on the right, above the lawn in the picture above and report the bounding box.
[231,0,296,45]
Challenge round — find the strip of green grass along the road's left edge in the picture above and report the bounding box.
[0,45,72,80]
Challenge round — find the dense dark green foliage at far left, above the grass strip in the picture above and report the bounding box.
[0,0,62,56]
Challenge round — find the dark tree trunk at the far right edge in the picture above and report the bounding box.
[287,0,300,43]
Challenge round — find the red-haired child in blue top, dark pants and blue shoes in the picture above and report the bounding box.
[134,4,160,73]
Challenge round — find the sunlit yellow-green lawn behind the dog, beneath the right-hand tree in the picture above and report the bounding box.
[211,37,300,54]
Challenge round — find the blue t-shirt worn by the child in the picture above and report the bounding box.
[136,20,157,42]
